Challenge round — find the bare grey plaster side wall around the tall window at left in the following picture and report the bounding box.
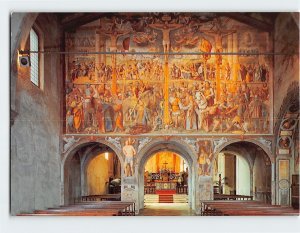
[11,14,62,215]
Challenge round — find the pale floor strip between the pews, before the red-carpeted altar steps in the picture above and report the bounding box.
[139,203,195,216]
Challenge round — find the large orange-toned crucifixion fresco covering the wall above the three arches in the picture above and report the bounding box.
[65,13,273,135]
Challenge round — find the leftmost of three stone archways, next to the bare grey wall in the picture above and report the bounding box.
[61,139,123,204]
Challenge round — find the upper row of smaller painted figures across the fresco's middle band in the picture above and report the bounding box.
[70,58,269,83]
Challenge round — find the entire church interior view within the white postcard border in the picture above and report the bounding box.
[10,12,299,216]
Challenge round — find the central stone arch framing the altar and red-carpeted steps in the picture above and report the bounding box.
[137,140,197,210]
